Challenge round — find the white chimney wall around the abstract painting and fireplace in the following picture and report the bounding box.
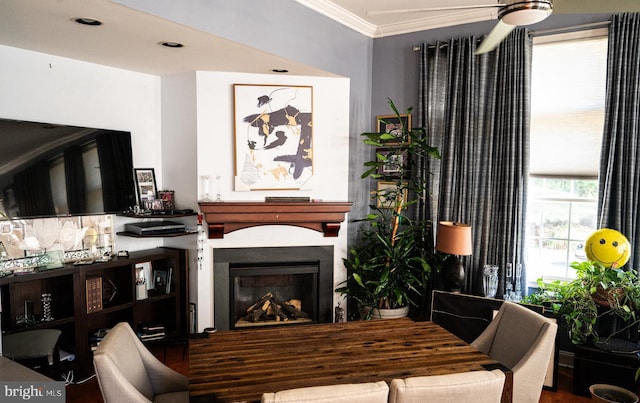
[197,72,349,329]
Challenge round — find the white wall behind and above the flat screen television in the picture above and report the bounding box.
[0,45,168,256]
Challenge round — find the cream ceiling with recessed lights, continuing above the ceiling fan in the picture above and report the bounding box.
[0,0,639,76]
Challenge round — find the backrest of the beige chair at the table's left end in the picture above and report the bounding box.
[93,322,154,403]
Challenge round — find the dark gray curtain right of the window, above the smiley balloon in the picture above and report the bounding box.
[598,13,640,269]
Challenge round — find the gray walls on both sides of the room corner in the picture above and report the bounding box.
[114,0,609,251]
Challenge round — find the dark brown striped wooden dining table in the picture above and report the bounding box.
[189,318,513,403]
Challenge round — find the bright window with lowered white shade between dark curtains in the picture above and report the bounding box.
[526,30,607,284]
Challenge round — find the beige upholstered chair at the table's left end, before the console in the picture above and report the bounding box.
[93,322,189,403]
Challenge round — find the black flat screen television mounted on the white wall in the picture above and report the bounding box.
[0,119,136,218]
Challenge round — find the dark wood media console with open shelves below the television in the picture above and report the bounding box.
[0,248,188,381]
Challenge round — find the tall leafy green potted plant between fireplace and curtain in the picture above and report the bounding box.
[336,99,440,318]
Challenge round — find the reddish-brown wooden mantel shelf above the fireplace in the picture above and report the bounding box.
[198,201,352,239]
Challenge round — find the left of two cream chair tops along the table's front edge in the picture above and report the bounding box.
[262,381,389,403]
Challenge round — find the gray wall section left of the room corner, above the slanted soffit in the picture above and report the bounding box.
[115,0,373,248]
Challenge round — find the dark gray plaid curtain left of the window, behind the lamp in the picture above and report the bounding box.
[417,28,532,296]
